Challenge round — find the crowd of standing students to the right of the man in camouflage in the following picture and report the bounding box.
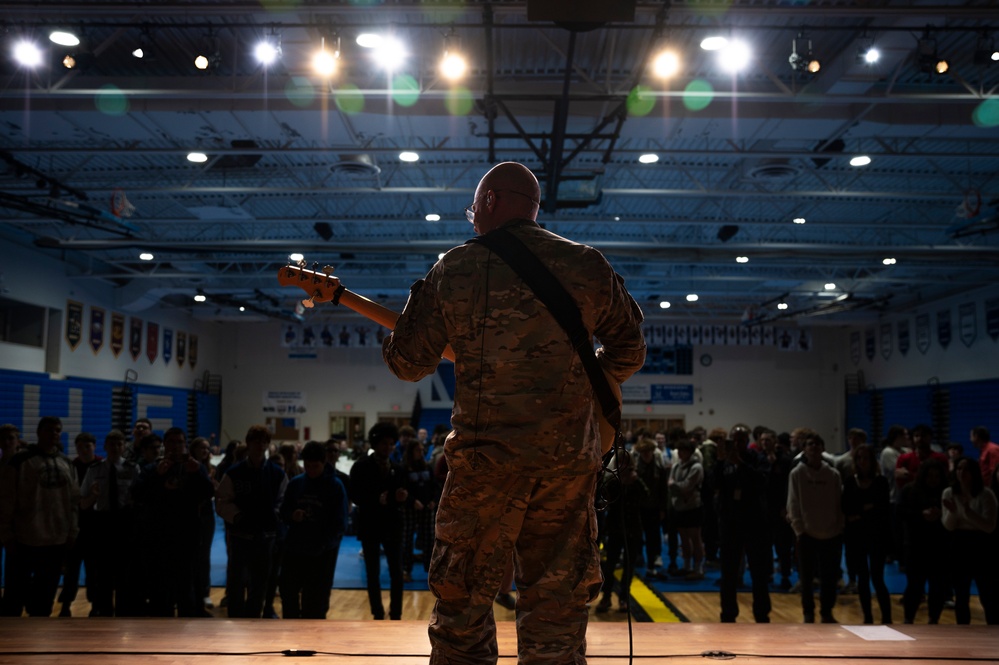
[596,424,999,624]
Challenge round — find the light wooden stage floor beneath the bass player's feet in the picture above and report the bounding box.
[0,618,999,665]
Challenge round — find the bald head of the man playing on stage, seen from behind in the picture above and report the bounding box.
[473,162,541,234]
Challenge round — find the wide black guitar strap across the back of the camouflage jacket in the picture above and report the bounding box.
[465,228,621,455]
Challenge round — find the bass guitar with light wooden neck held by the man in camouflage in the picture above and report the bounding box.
[278,261,621,455]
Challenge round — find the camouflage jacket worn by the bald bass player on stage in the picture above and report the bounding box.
[383,219,645,476]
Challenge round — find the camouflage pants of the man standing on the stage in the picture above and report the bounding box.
[429,469,600,665]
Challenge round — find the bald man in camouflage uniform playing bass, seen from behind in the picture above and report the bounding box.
[383,162,645,665]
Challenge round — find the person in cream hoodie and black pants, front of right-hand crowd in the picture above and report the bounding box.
[787,434,845,623]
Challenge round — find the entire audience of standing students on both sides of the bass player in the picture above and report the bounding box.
[0,416,999,624]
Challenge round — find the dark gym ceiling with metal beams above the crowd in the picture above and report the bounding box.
[0,0,999,324]
